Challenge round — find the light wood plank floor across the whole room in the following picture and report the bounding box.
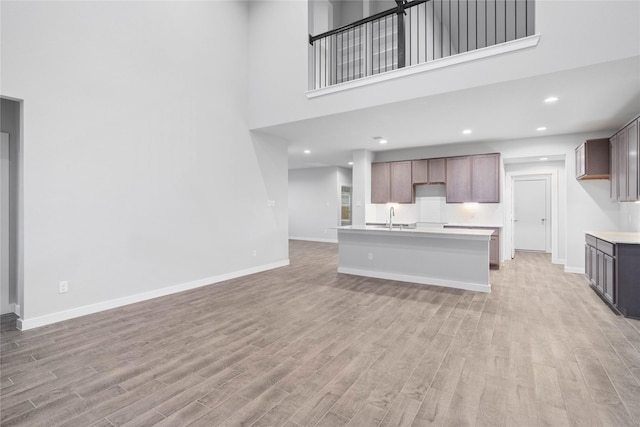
[0,241,640,427]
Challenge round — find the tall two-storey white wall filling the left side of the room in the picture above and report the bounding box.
[1,1,288,328]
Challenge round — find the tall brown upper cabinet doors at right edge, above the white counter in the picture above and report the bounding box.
[609,113,640,202]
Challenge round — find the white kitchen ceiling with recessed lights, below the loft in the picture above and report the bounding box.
[255,57,640,169]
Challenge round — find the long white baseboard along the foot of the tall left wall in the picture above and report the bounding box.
[17,259,289,331]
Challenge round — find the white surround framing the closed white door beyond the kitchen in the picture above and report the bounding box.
[504,168,564,264]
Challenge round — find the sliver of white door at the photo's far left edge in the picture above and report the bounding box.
[0,133,12,314]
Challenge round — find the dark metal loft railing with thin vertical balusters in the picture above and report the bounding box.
[309,0,534,89]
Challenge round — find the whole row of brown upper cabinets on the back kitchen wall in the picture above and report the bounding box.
[371,153,500,203]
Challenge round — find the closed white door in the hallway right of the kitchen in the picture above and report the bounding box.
[513,179,548,251]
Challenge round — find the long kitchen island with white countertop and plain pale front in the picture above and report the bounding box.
[338,226,493,292]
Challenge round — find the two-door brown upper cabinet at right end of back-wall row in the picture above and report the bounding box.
[447,153,500,203]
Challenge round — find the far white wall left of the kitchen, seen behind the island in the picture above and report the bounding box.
[289,167,351,242]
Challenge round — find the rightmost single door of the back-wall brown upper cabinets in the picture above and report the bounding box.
[471,154,500,203]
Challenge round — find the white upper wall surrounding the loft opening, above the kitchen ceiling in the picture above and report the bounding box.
[250,0,640,128]
